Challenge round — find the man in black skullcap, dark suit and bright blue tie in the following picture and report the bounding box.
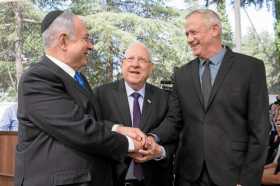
[15,11,145,186]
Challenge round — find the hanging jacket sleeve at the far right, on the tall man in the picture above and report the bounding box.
[240,61,270,186]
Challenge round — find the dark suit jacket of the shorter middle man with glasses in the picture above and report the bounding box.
[94,80,178,186]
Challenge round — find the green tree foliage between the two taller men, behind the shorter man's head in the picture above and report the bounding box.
[82,12,190,84]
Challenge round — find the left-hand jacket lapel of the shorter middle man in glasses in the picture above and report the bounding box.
[113,80,132,126]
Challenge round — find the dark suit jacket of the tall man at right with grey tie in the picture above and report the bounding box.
[154,48,270,186]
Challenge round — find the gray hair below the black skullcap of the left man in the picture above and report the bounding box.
[42,11,76,49]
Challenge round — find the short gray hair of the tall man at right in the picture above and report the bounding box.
[185,9,222,31]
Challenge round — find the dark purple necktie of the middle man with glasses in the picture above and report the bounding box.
[131,92,143,180]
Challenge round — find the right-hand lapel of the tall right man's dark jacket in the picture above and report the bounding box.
[207,48,234,109]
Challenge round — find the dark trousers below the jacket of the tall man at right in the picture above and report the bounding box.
[175,164,218,186]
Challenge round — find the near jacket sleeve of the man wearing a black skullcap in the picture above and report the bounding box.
[19,70,128,160]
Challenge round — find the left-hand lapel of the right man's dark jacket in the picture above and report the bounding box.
[192,58,204,108]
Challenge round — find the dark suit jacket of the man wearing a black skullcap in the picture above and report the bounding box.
[15,57,128,186]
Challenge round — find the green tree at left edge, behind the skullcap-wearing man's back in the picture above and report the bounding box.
[0,1,41,98]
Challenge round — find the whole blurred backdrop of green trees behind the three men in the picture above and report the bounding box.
[0,0,280,101]
